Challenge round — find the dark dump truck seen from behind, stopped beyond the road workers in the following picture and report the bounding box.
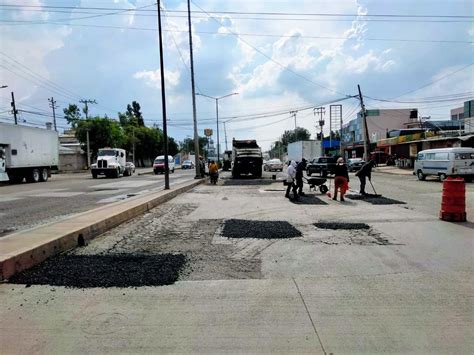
[231,139,263,178]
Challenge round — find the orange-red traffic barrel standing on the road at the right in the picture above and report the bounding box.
[439,177,466,222]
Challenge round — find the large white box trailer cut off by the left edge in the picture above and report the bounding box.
[0,123,59,183]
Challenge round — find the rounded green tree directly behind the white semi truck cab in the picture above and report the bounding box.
[75,117,126,157]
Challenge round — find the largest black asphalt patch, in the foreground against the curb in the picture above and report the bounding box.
[9,254,186,288]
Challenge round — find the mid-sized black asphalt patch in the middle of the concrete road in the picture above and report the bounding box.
[222,219,302,239]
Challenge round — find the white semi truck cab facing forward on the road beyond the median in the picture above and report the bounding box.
[91,148,133,179]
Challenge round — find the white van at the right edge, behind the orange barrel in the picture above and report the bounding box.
[413,148,474,182]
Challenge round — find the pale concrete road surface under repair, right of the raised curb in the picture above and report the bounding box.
[0,174,474,354]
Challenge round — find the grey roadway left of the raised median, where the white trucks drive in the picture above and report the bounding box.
[0,169,195,237]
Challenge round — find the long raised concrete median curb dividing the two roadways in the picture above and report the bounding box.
[0,179,204,280]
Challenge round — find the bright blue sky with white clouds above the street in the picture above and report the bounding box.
[0,0,474,149]
